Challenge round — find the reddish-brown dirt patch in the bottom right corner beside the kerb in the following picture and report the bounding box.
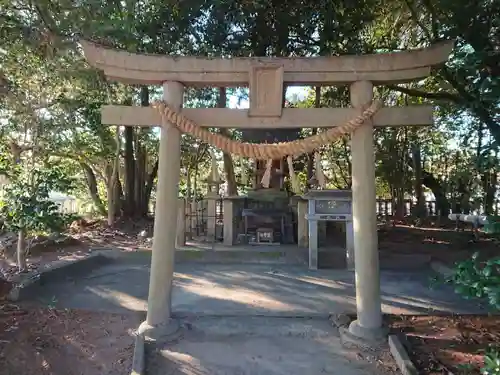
[385,315,500,375]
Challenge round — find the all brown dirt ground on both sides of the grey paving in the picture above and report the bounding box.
[0,222,500,375]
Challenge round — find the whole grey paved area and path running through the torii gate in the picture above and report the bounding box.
[17,252,486,375]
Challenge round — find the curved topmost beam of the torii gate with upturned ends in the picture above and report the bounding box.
[81,41,454,86]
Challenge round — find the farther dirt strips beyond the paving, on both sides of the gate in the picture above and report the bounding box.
[0,220,500,279]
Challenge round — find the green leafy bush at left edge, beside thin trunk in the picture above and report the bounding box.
[0,165,73,232]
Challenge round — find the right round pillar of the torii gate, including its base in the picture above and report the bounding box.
[349,81,386,341]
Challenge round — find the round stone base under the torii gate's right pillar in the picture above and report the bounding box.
[339,320,389,349]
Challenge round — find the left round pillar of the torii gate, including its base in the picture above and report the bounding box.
[139,82,184,339]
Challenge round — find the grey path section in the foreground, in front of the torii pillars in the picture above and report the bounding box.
[148,317,397,375]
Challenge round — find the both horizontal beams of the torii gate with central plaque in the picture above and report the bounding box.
[81,41,454,129]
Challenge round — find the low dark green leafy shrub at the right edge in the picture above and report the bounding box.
[445,253,500,310]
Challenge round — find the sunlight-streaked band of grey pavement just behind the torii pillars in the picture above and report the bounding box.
[77,271,453,314]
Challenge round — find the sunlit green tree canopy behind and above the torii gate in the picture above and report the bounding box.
[0,0,500,219]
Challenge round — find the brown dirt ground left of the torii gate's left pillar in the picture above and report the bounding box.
[0,222,145,375]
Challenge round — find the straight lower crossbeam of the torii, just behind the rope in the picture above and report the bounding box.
[102,105,433,129]
